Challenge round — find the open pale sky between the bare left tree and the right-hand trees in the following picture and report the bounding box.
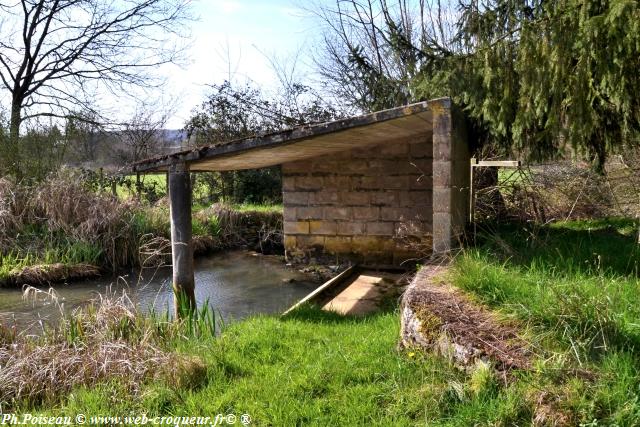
[160,0,317,129]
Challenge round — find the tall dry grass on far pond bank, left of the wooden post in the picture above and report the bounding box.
[0,169,169,274]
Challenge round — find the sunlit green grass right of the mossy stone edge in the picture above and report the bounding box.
[451,218,640,425]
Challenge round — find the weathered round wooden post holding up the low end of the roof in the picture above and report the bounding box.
[168,163,196,317]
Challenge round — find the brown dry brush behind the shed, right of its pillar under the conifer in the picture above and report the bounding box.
[475,156,640,224]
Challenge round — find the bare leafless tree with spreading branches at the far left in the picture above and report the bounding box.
[0,0,189,176]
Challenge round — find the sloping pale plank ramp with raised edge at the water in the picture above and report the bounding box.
[283,266,401,315]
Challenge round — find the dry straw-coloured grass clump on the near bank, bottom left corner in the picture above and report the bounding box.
[0,288,216,409]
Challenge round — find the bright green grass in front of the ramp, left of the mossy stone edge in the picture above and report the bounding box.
[18,308,540,426]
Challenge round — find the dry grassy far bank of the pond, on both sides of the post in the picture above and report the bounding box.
[0,169,282,286]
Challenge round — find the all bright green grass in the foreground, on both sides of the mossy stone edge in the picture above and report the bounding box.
[2,220,640,426]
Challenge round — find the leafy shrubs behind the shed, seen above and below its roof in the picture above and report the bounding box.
[185,82,338,203]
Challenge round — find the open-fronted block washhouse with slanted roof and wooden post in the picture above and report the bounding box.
[133,98,470,310]
